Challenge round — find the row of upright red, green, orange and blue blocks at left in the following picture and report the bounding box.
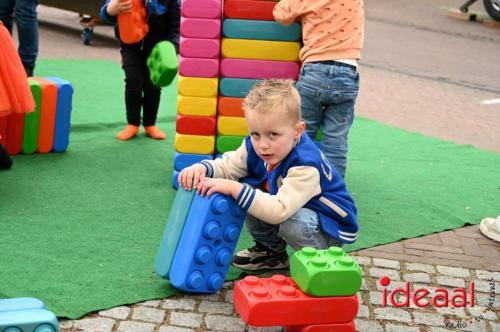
[0,77,73,155]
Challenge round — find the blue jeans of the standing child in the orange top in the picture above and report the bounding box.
[297,63,359,177]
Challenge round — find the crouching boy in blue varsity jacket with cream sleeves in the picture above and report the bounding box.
[179,80,358,270]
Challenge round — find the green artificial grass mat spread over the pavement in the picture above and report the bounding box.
[0,60,500,319]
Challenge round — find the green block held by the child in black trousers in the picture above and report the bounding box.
[146,40,179,87]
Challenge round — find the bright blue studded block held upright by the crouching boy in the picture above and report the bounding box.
[170,194,246,293]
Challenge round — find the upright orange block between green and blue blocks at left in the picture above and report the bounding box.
[33,77,57,153]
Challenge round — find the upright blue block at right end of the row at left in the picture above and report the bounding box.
[45,77,73,152]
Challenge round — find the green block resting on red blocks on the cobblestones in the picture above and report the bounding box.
[290,247,362,296]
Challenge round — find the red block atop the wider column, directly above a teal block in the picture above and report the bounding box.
[223,0,276,21]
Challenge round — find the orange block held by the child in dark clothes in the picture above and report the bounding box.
[118,0,149,44]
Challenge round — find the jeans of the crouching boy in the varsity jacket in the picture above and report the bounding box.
[245,208,342,251]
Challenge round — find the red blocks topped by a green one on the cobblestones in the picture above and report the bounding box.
[234,247,362,332]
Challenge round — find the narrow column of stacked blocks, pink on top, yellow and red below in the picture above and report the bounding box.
[173,0,222,187]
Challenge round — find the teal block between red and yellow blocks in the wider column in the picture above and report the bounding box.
[222,19,302,41]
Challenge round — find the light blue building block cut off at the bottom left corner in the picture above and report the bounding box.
[0,297,59,332]
